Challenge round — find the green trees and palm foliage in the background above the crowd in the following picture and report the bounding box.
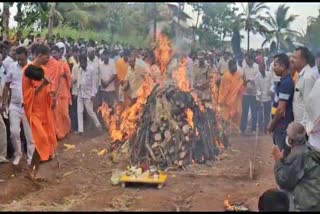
[4,2,308,52]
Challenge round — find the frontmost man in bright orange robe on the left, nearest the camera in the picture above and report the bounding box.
[22,45,57,179]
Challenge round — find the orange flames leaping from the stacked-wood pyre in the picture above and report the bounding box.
[99,31,223,159]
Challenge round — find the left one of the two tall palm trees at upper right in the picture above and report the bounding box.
[239,2,269,52]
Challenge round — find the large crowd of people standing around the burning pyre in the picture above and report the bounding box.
[0,32,320,210]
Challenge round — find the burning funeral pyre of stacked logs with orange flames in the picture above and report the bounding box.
[100,35,227,168]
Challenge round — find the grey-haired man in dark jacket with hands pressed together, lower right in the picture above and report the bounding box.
[273,122,320,211]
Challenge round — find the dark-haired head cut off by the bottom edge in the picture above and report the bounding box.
[258,189,290,212]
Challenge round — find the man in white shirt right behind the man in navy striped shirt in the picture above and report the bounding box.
[293,47,318,128]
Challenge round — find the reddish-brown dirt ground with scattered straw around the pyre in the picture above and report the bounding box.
[0,130,276,211]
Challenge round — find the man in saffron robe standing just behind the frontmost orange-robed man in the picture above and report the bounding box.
[51,46,71,140]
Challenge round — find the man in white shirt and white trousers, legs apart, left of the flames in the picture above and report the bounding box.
[73,55,102,134]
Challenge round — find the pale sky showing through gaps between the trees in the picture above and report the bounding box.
[0,2,320,49]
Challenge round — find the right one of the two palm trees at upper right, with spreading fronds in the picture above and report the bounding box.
[262,4,299,50]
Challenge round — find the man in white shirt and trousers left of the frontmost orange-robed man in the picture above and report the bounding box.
[2,47,35,165]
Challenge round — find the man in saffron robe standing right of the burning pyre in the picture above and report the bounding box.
[218,59,244,127]
